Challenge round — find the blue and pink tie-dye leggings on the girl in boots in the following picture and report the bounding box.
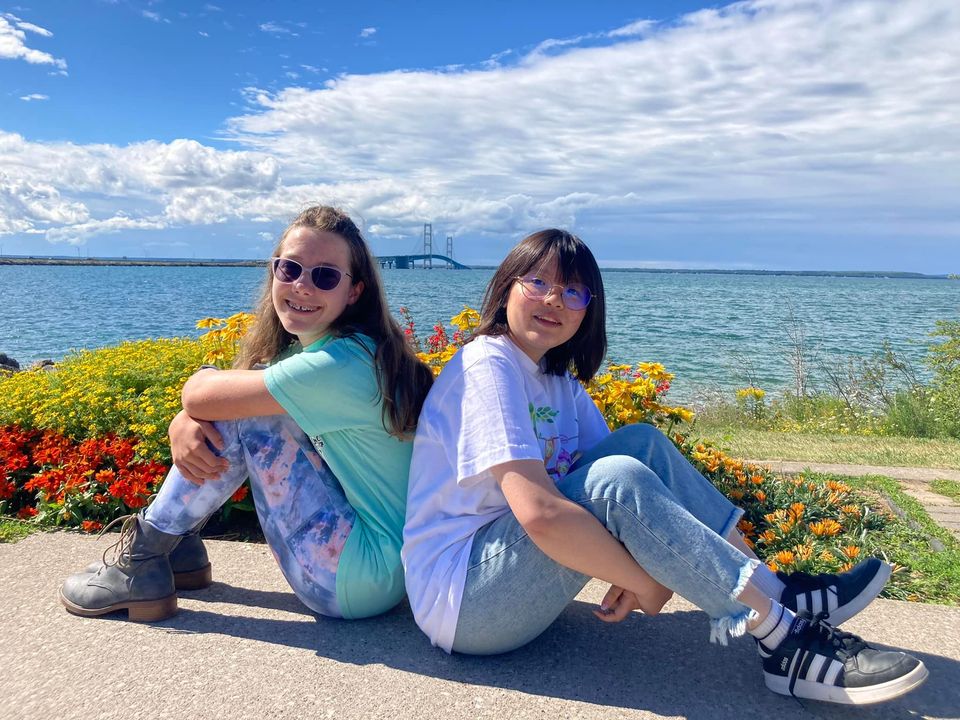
[144,415,356,617]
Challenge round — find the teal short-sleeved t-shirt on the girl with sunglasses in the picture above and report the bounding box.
[264,335,413,618]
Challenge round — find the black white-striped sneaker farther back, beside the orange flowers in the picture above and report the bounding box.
[777,558,891,625]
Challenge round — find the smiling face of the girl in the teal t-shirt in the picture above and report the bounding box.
[271,227,363,347]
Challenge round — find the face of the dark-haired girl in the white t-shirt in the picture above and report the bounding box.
[507,262,586,362]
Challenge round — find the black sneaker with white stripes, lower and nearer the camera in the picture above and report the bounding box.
[759,611,927,705]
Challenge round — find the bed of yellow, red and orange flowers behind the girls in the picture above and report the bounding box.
[0,308,944,599]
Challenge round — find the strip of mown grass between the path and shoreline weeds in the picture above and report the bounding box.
[691,420,960,470]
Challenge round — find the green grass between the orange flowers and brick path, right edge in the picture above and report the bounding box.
[828,475,960,605]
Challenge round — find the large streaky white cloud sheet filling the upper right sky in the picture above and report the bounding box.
[230,0,960,235]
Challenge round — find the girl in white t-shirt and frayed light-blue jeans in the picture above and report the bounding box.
[402,230,926,703]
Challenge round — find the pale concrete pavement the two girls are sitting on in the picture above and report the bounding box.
[0,532,960,720]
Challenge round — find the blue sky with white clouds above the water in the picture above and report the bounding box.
[0,0,960,274]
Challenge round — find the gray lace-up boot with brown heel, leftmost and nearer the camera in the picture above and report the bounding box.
[59,515,180,622]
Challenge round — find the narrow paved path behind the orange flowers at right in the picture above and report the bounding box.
[749,460,960,540]
